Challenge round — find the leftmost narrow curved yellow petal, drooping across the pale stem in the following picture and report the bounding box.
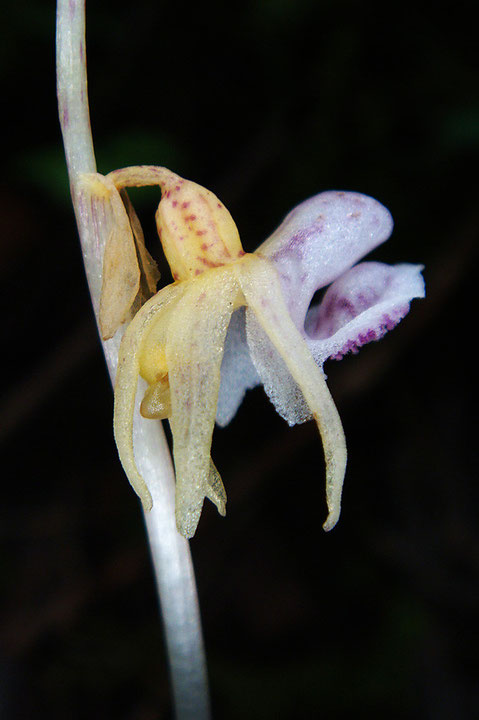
[113,284,186,510]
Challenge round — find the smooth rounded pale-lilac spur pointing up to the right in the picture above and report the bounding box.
[257,191,393,327]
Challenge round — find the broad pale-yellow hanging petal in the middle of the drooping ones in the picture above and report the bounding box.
[166,267,240,537]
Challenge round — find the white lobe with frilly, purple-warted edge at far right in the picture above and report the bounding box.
[305,262,425,365]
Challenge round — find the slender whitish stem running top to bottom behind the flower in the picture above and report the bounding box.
[57,0,210,720]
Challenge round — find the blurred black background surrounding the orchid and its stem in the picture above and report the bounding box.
[0,0,479,720]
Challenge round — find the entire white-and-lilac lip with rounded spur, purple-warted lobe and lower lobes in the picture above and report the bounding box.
[216,191,425,425]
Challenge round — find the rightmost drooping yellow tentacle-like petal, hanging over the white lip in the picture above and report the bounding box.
[234,255,346,530]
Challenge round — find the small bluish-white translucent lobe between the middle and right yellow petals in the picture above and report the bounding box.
[216,307,261,427]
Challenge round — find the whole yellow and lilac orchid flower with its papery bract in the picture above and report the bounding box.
[81,166,424,538]
